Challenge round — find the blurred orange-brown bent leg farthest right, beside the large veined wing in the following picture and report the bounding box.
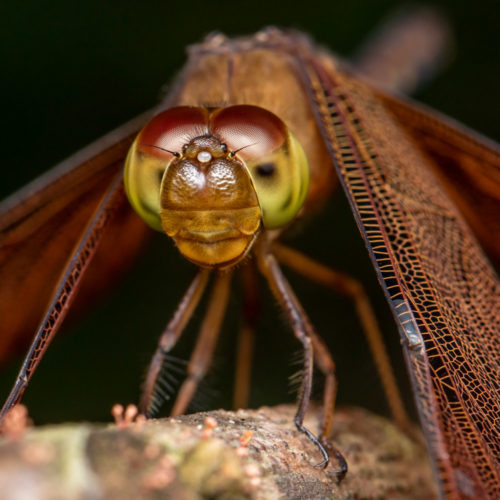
[273,243,413,432]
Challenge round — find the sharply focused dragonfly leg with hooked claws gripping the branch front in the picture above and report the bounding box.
[255,237,347,474]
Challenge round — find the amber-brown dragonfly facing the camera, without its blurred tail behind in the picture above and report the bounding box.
[0,8,500,498]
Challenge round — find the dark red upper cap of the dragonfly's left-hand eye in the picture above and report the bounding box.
[137,106,208,160]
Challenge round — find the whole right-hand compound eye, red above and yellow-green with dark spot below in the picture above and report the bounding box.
[210,105,309,229]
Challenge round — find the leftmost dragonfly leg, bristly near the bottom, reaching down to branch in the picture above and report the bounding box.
[139,269,210,416]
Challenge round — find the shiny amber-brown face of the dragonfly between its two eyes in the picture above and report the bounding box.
[160,132,261,267]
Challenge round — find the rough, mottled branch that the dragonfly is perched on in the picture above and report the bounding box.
[0,406,436,500]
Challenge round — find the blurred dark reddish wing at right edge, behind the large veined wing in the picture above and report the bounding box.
[379,94,500,265]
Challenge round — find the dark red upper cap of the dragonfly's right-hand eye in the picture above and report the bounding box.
[210,105,288,160]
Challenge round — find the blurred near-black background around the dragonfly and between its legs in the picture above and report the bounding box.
[0,0,500,423]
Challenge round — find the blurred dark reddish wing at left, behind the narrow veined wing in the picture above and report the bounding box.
[0,115,151,362]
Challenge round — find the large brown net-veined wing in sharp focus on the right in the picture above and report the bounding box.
[301,52,500,499]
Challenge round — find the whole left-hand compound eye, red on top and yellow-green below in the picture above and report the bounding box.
[124,106,208,231]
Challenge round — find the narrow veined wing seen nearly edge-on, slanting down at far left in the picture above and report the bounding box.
[0,175,127,423]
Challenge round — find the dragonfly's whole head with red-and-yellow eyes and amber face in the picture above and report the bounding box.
[125,105,308,268]
